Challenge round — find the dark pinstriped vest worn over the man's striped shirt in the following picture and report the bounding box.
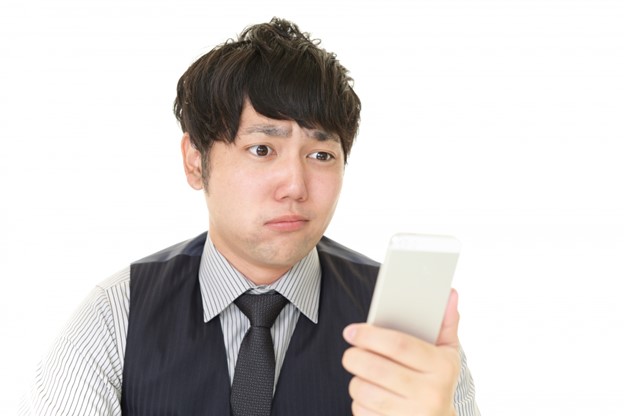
[121,233,379,416]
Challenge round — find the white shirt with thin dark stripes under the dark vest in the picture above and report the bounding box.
[18,240,479,416]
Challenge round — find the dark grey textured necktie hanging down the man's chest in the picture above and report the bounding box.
[230,293,288,416]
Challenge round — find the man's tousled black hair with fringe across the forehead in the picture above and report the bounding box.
[174,18,361,162]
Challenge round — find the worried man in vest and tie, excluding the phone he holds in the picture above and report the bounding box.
[18,19,478,415]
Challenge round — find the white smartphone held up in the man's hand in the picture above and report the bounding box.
[367,234,461,344]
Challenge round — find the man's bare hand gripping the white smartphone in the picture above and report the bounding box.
[342,290,461,416]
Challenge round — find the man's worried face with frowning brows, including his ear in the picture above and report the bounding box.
[183,104,344,284]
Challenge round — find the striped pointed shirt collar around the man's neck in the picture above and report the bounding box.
[199,237,321,323]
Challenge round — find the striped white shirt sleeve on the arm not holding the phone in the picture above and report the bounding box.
[19,272,129,416]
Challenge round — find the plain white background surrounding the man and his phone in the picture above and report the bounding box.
[0,0,624,415]
